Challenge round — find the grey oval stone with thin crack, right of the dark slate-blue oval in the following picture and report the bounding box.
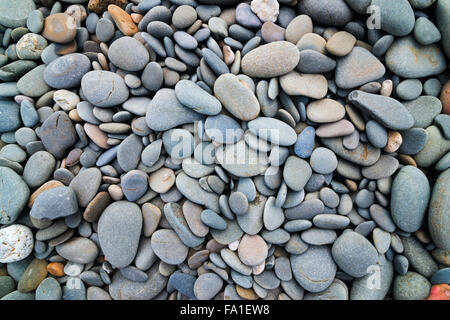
[81,70,129,107]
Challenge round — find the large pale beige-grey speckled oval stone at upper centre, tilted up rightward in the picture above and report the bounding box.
[241,41,300,78]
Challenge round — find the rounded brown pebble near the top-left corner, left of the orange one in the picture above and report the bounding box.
[42,13,77,43]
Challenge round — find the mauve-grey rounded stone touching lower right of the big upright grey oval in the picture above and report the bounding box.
[152,229,188,265]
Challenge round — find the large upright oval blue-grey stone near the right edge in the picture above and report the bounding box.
[391,166,430,232]
